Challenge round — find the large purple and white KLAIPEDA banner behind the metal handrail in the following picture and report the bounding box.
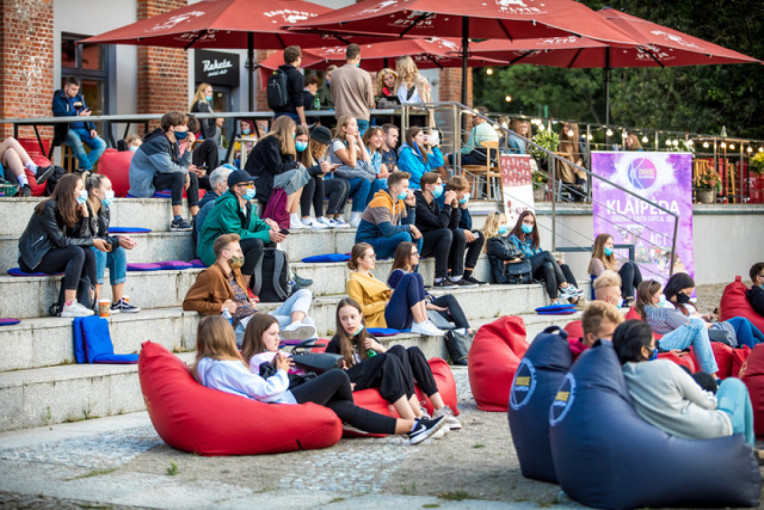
[592,152,695,283]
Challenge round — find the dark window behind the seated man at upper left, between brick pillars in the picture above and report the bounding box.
[61,33,109,115]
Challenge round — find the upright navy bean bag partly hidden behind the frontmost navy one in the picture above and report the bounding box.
[508,326,573,483]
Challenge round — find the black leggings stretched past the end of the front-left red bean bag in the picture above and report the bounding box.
[291,368,396,434]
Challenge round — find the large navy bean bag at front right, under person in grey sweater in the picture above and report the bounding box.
[549,344,761,508]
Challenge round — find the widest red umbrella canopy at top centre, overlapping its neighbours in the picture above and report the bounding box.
[289,0,634,44]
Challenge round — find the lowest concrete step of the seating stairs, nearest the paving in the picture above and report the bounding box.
[0,316,575,431]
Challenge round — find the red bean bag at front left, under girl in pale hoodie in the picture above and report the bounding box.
[138,342,342,455]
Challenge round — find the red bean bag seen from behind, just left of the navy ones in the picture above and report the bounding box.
[467,316,528,412]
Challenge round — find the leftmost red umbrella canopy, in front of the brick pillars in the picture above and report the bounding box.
[83,0,346,49]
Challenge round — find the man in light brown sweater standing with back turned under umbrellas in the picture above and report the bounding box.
[332,43,374,136]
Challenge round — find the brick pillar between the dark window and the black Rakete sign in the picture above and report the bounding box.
[137,0,189,127]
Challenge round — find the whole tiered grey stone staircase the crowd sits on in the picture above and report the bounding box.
[0,198,583,431]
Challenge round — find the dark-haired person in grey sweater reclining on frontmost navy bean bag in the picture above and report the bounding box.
[613,320,755,446]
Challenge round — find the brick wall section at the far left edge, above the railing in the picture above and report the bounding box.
[0,0,54,139]
